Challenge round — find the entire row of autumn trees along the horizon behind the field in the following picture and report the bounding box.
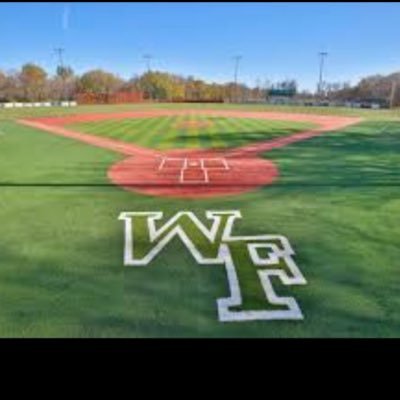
[0,63,400,106]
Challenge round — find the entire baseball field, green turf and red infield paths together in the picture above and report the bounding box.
[0,104,400,337]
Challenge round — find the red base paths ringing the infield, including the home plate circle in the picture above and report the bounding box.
[19,110,361,199]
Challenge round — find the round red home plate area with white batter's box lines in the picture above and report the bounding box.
[108,151,278,199]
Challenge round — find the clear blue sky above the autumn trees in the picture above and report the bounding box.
[0,2,400,90]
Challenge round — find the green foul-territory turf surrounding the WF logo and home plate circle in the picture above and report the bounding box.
[0,113,400,337]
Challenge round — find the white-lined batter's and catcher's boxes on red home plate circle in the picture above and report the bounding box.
[158,157,230,183]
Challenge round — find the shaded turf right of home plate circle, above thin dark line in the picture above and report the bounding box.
[263,122,400,190]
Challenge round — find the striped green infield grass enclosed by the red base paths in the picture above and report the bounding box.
[69,115,314,149]
